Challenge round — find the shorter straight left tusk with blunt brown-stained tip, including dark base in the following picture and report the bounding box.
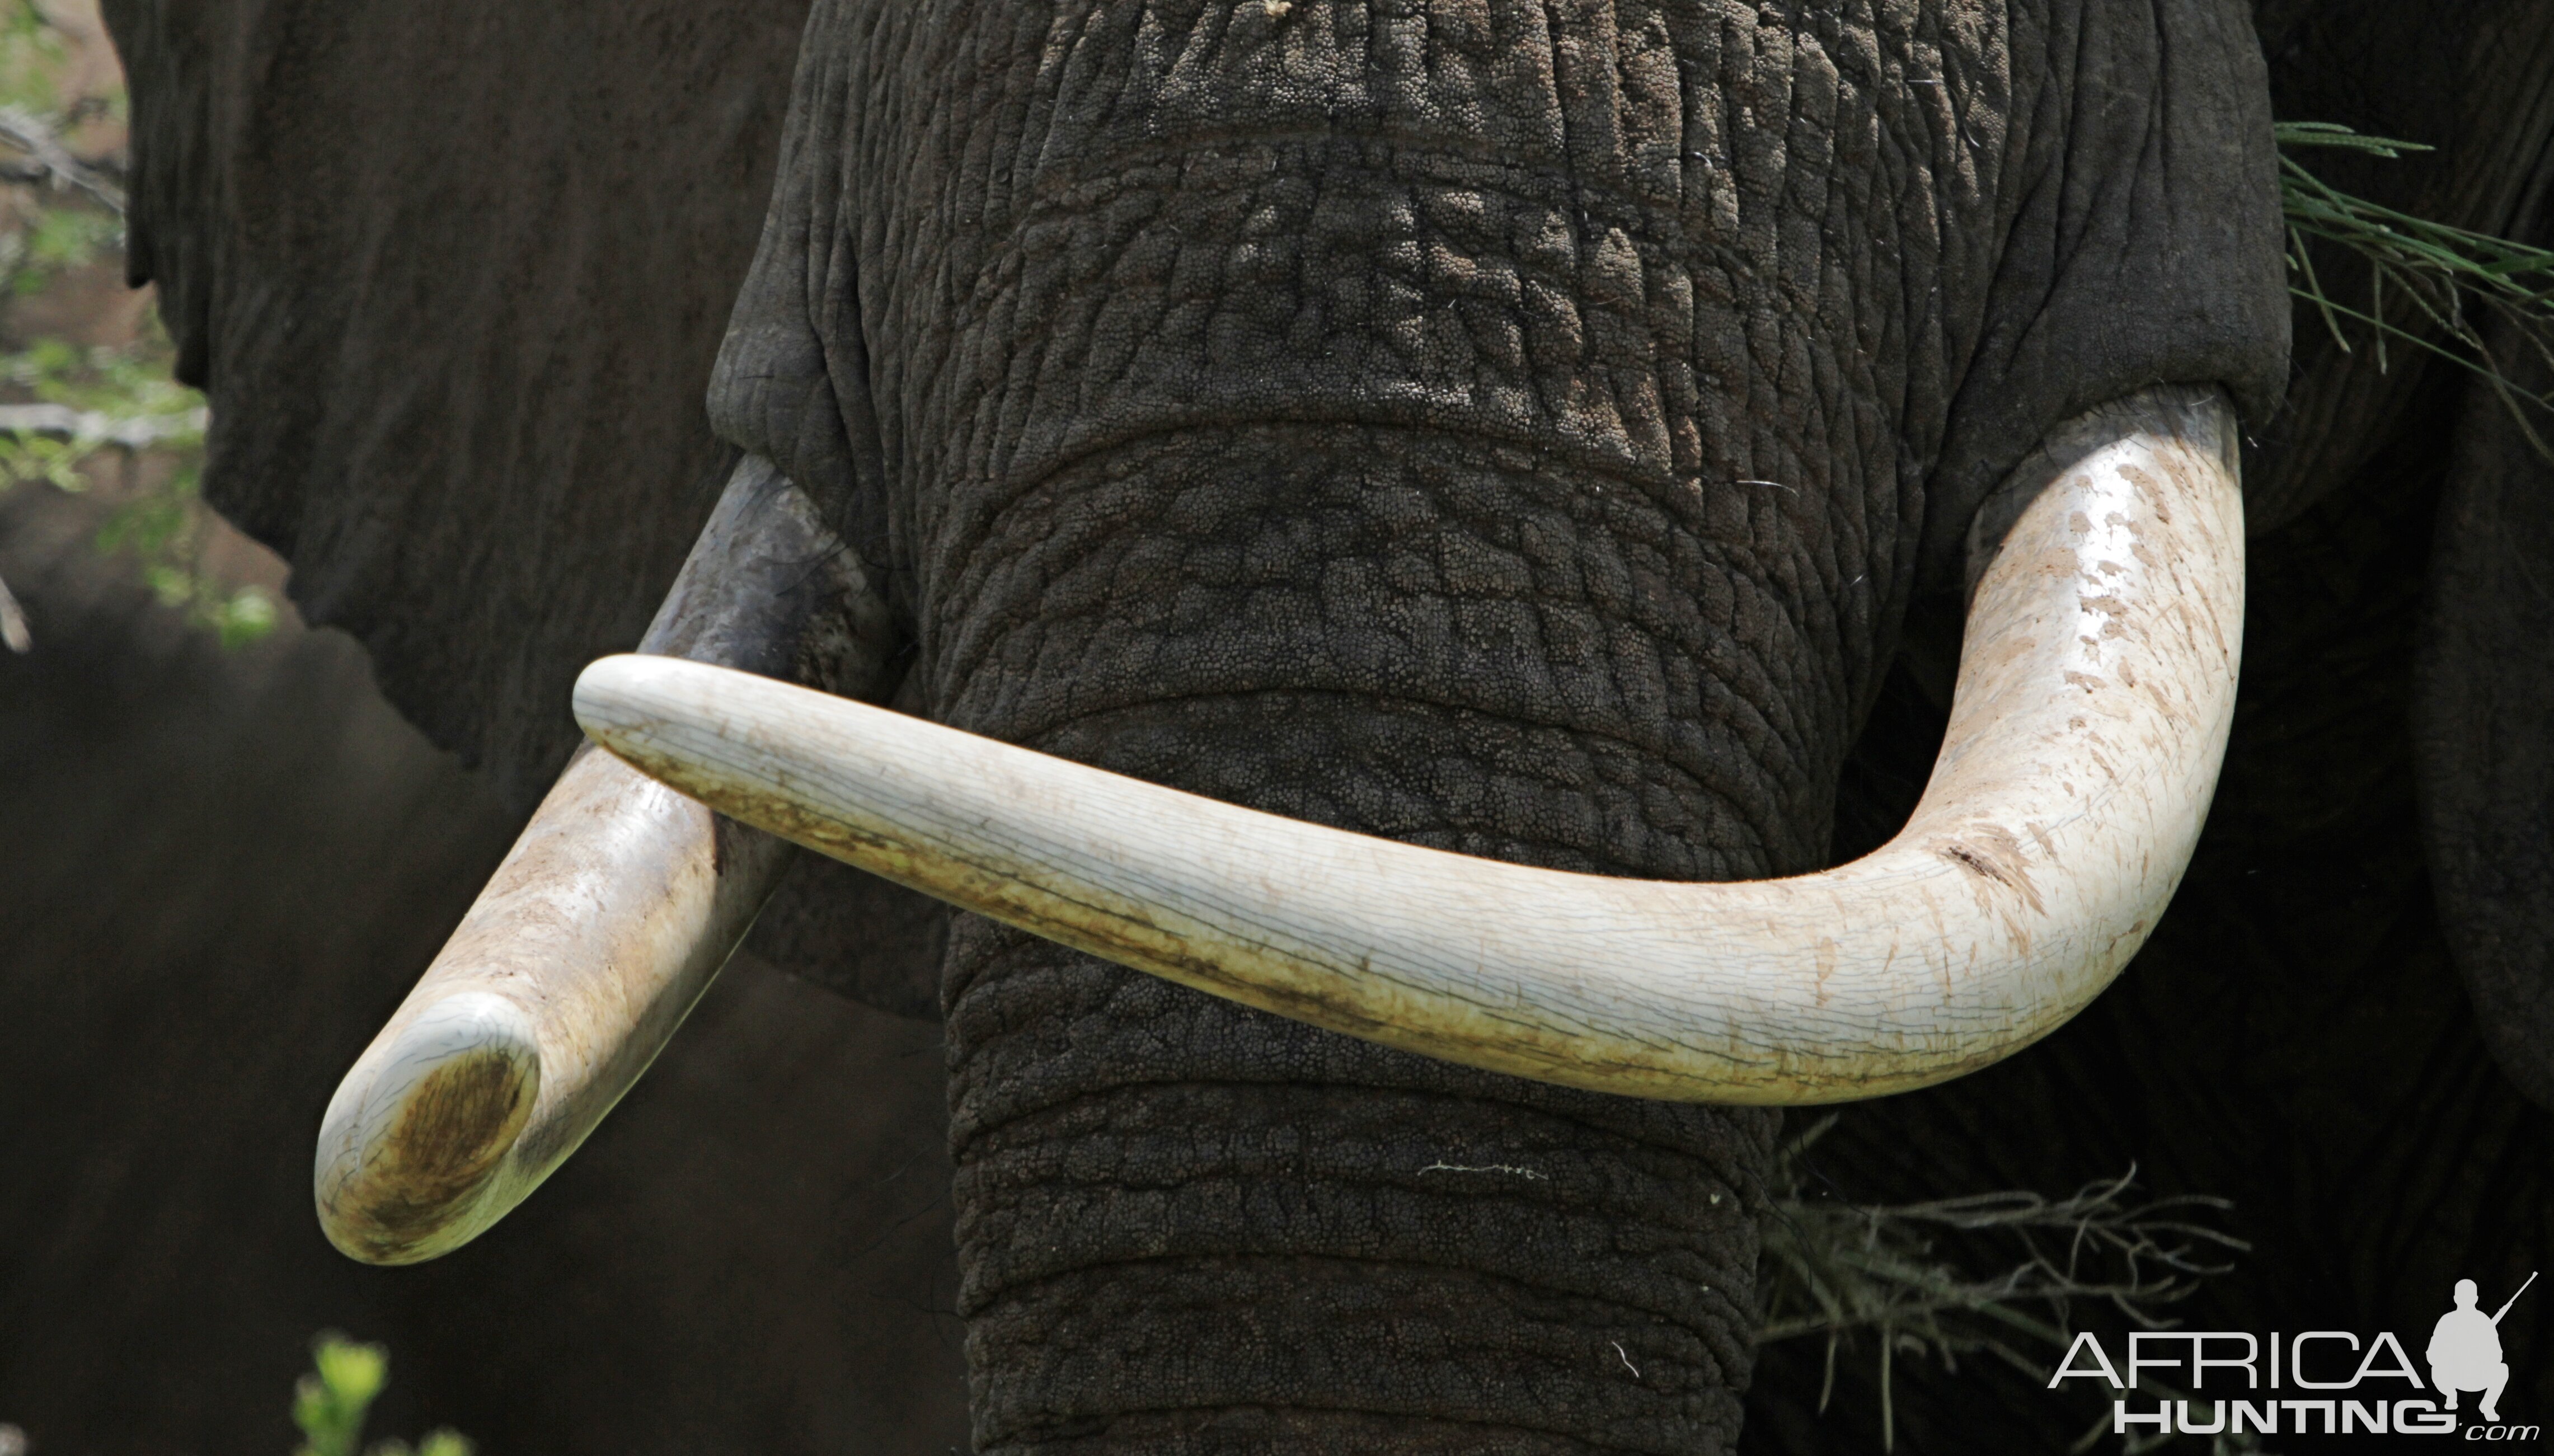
[314,460,886,1265]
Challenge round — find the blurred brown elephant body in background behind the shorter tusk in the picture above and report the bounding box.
[0,488,965,1456]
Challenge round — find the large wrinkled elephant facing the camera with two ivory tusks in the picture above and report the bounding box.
[90,0,2549,1453]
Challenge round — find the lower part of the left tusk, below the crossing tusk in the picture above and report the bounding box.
[314,735,787,1265]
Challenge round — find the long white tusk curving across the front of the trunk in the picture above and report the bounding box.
[577,391,2242,1103]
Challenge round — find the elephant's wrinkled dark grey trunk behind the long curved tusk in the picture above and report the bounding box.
[932,426,1787,1456]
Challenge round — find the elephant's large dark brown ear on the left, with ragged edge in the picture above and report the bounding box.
[105,0,807,807]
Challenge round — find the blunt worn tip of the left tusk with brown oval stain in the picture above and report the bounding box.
[314,991,542,1265]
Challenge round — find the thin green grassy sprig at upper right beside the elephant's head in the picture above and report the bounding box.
[2276,123,2554,447]
